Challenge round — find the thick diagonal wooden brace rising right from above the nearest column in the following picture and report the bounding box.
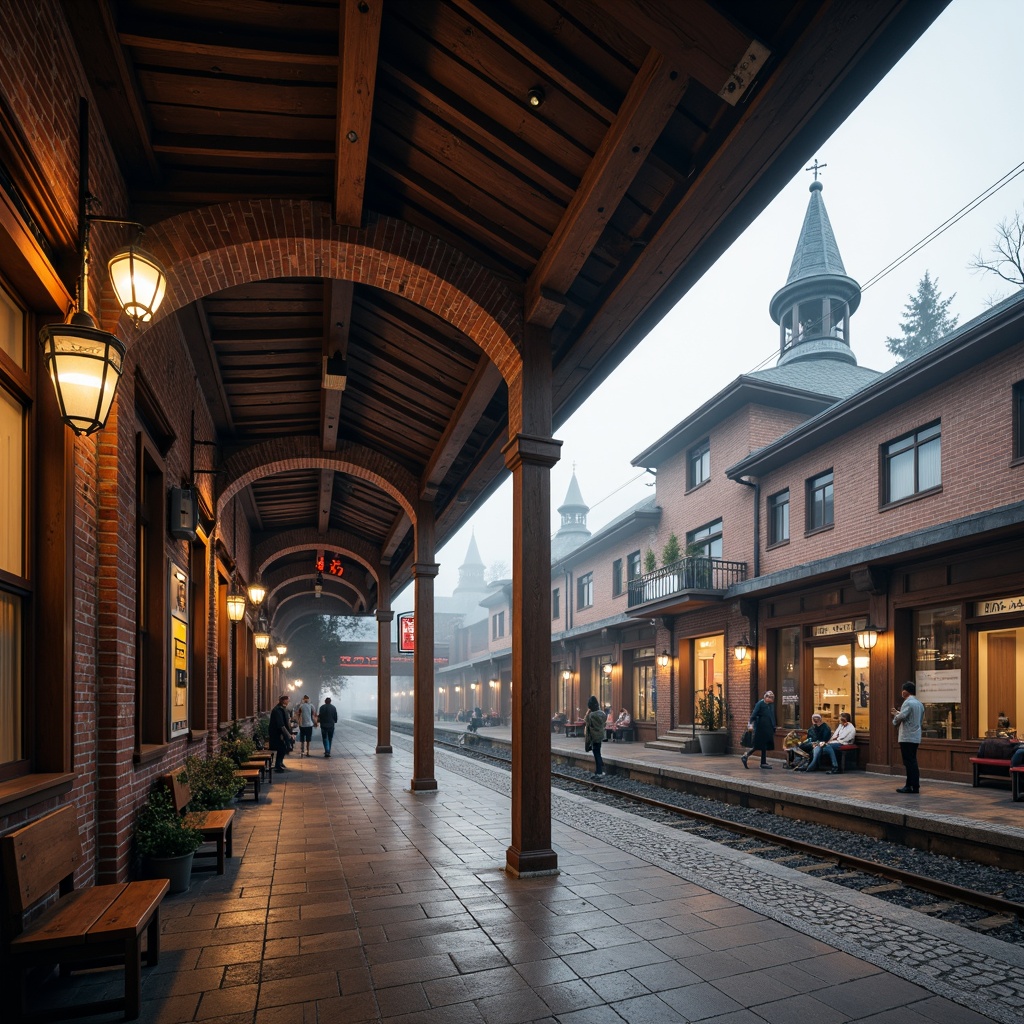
[524,50,687,328]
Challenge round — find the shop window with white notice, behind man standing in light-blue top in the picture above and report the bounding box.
[913,604,962,739]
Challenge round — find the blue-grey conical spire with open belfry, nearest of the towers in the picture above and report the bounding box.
[768,177,860,366]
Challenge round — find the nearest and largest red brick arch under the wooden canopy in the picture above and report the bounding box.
[125,199,522,381]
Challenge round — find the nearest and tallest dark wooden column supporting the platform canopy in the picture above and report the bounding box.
[503,325,561,877]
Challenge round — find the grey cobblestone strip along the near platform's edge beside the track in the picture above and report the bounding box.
[425,751,1024,1024]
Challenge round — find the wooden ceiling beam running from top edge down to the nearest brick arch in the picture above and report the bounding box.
[334,0,384,227]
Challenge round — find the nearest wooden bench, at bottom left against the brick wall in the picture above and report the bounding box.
[0,804,170,1020]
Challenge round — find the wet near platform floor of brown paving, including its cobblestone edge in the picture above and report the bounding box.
[32,722,1024,1024]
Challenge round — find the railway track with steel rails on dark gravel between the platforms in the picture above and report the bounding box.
[435,738,1024,943]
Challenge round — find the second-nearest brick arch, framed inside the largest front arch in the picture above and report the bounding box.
[217,436,419,524]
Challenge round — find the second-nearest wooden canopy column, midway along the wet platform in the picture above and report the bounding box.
[410,502,439,793]
